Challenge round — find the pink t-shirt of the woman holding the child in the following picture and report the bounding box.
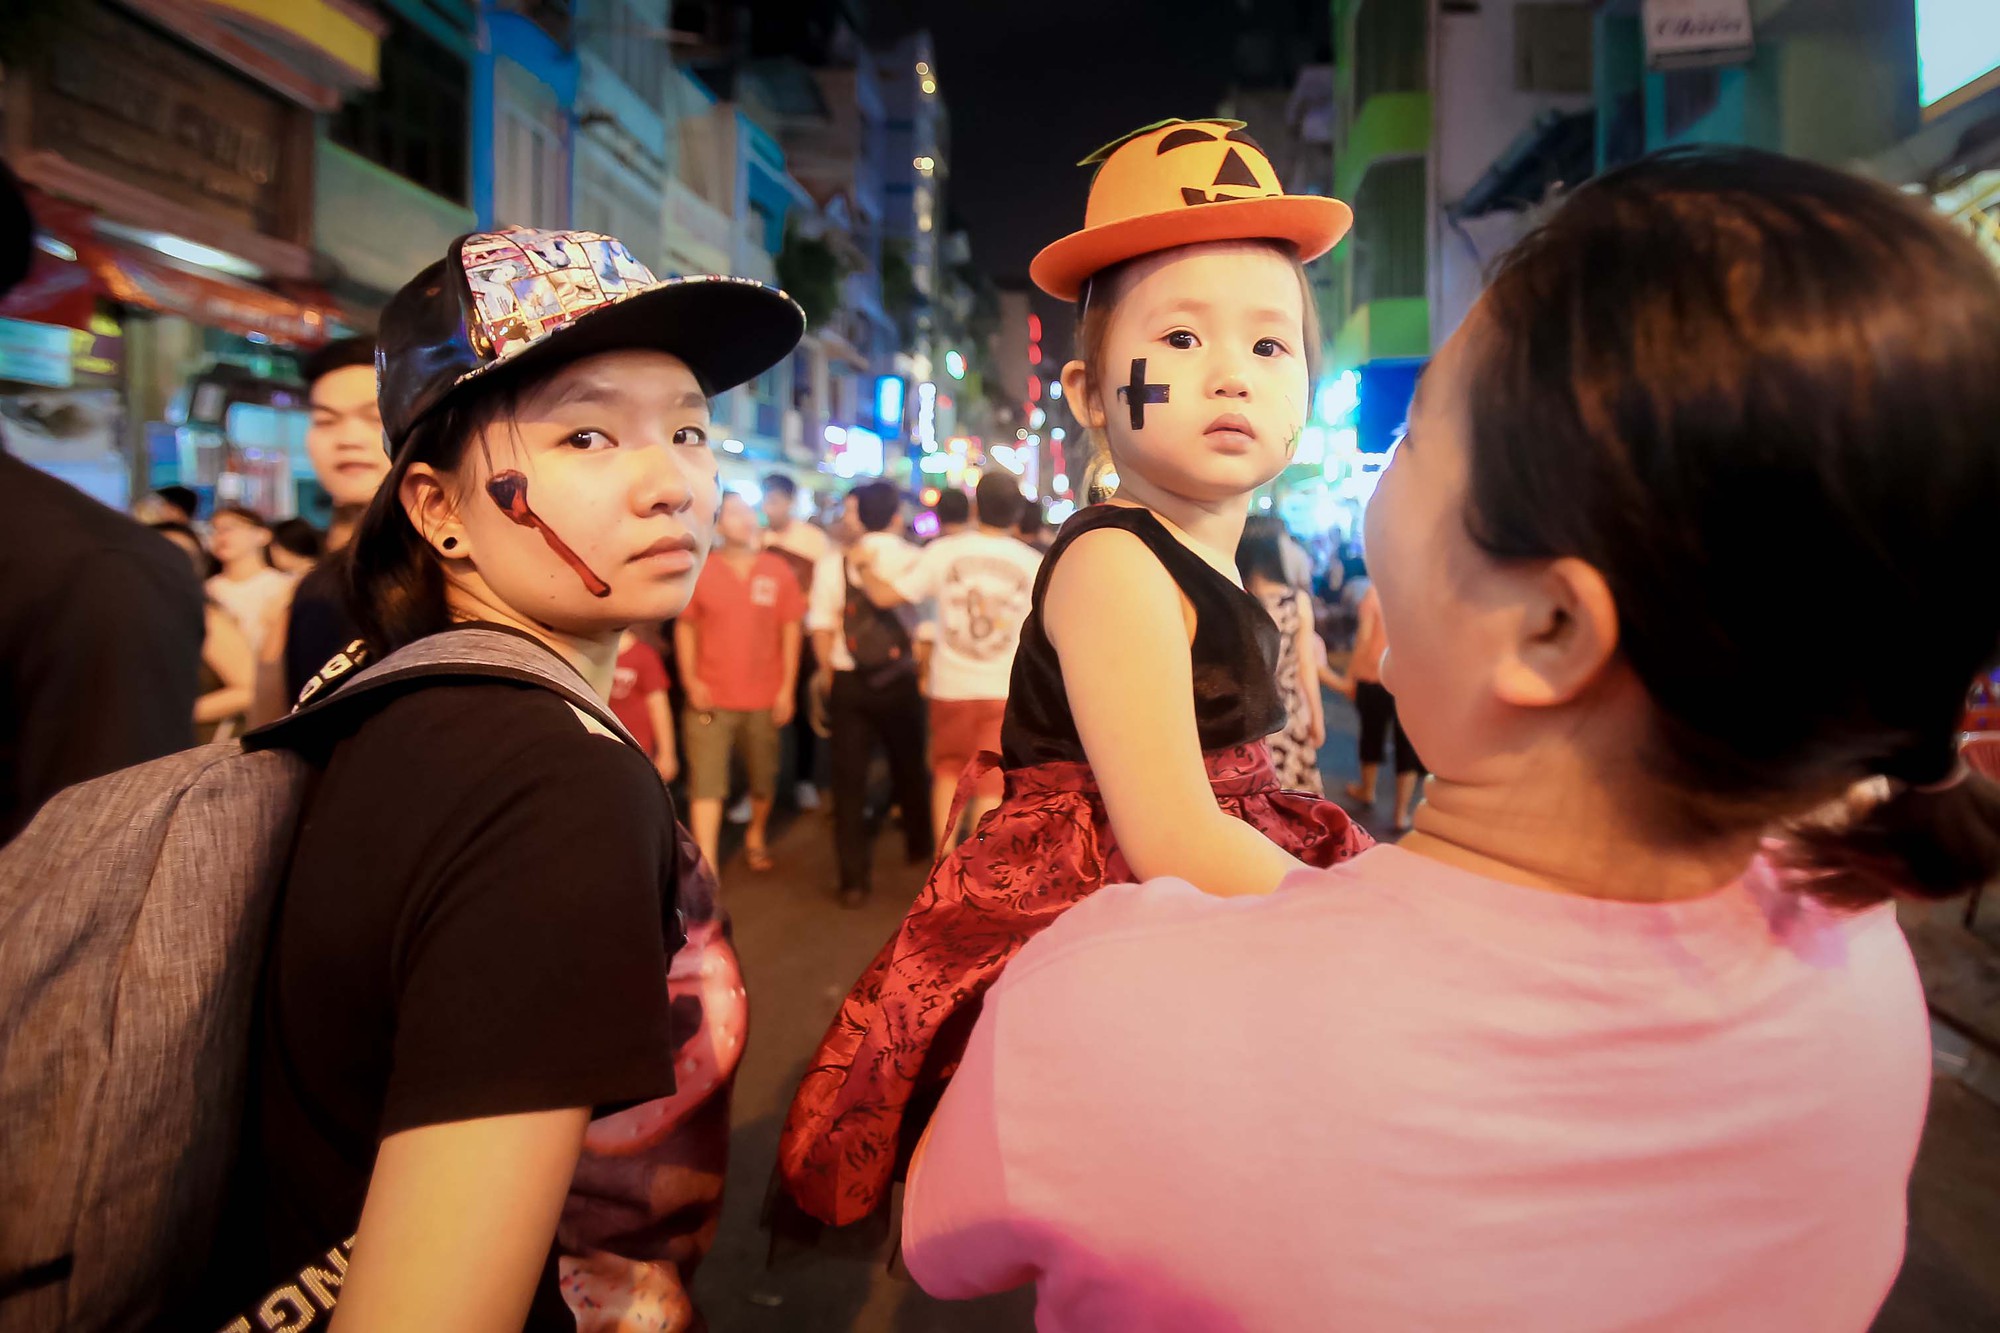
[902,847,1930,1333]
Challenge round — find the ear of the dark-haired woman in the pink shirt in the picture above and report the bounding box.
[1494,556,1618,709]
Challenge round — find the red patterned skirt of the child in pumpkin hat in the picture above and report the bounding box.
[768,741,1370,1231]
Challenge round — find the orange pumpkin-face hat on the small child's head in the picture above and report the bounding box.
[1028,120,1354,300]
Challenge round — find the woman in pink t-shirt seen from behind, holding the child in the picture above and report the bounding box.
[904,150,2000,1333]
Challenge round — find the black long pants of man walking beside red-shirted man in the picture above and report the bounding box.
[828,671,936,889]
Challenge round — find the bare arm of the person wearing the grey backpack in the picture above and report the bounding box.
[332,1107,590,1333]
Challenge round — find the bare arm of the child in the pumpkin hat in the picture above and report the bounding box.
[1042,528,1302,895]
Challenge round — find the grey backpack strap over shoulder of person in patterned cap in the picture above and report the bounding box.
[244,624,642,751]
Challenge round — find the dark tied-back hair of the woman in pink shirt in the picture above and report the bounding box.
[1466,148,2000,905]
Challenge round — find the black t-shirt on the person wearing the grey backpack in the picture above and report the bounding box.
[204,681,680,1333]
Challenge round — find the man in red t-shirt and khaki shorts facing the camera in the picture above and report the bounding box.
[674,494,806,873]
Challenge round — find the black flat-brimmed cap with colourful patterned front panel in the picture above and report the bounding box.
[376,226,806,454]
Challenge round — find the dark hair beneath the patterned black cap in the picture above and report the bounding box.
[332,376,528,656]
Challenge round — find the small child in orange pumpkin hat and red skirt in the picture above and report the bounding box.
[774,120,1368,1225]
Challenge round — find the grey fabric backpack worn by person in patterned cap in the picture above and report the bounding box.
[0,628,636,1333]
